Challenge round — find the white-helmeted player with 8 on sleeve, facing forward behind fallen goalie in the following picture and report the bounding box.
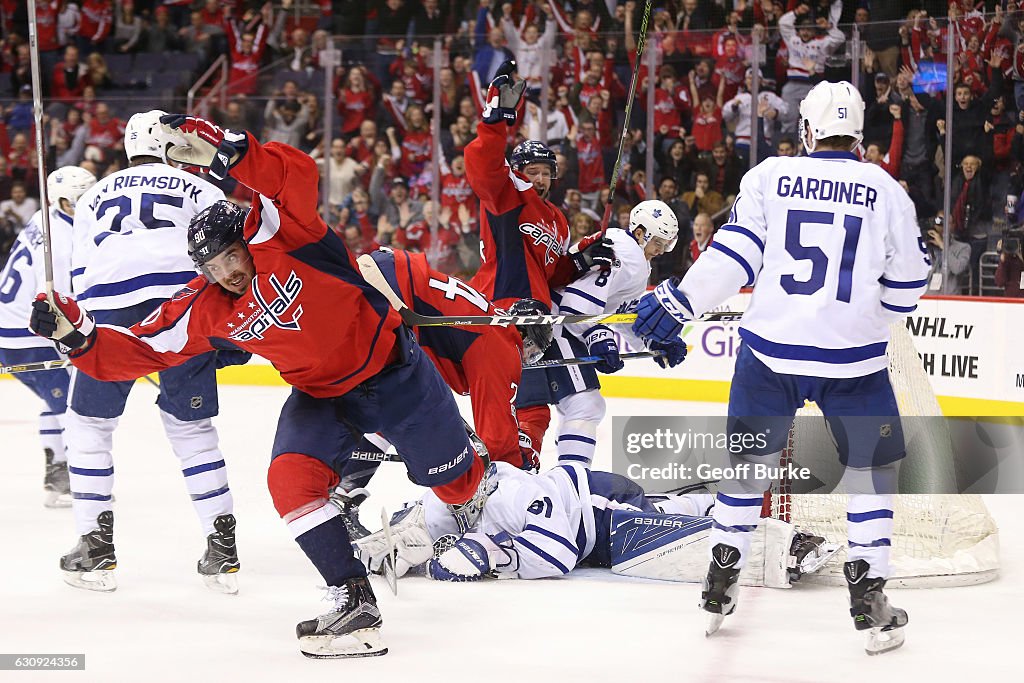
[516,200,686,467]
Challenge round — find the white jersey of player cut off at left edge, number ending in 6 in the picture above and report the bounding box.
[0,208,72,348]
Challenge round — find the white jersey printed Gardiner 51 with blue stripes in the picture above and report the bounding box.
[679,152,930,377]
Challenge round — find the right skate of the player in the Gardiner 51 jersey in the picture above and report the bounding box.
[843,560,909,654]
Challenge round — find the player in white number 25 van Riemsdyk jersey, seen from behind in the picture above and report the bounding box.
[60,110,248,593]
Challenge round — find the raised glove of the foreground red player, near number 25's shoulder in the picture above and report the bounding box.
[160,114,249,180]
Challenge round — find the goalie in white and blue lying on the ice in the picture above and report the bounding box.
[355,463,839,588]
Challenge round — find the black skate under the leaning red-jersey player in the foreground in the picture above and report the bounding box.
[295,577,387,659]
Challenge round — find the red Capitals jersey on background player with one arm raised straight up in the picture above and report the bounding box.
[465,122,569,308]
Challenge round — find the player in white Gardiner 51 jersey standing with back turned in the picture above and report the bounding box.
[634,82,930,654]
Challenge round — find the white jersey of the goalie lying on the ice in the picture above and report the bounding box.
[423,462,593,579]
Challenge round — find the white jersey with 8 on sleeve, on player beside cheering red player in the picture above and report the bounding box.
[552,227,650,349]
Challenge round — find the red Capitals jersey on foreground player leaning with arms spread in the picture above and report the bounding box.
[67,136,401,398]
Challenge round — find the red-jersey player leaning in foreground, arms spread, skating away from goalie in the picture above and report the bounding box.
[31,115,492,657]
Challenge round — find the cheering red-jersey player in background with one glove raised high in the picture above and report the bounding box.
[465,61,614,308]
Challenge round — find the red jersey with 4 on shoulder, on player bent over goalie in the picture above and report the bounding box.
[373,249,522,464]
